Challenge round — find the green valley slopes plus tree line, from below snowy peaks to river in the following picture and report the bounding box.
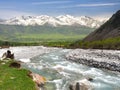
[0,24,95,47]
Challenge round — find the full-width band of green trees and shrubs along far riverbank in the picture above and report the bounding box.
[0,37,120,49]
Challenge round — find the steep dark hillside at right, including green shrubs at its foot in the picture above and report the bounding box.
[70,10,120,49]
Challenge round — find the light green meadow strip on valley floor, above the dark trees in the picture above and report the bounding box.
[9,34,86,43]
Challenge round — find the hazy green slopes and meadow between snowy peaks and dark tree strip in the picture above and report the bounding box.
[0,24,94,42]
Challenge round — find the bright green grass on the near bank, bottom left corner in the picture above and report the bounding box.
[0,61,36,90]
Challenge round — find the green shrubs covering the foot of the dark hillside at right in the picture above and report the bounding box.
[70,37,120,50]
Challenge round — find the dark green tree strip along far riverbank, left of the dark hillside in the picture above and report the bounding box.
[0,39,75,48]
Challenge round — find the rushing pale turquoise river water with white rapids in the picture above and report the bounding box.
[0,48,120,90]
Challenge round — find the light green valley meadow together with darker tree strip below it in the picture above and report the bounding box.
[0,34,85,47]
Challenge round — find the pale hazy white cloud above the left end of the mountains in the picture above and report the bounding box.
[0,10,35,19]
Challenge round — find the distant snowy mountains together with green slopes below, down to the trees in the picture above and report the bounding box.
[0,15,104,43]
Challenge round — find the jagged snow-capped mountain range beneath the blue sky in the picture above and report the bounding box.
[0,15,104,28]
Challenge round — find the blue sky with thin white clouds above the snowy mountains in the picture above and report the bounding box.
[0,0,120,19]
